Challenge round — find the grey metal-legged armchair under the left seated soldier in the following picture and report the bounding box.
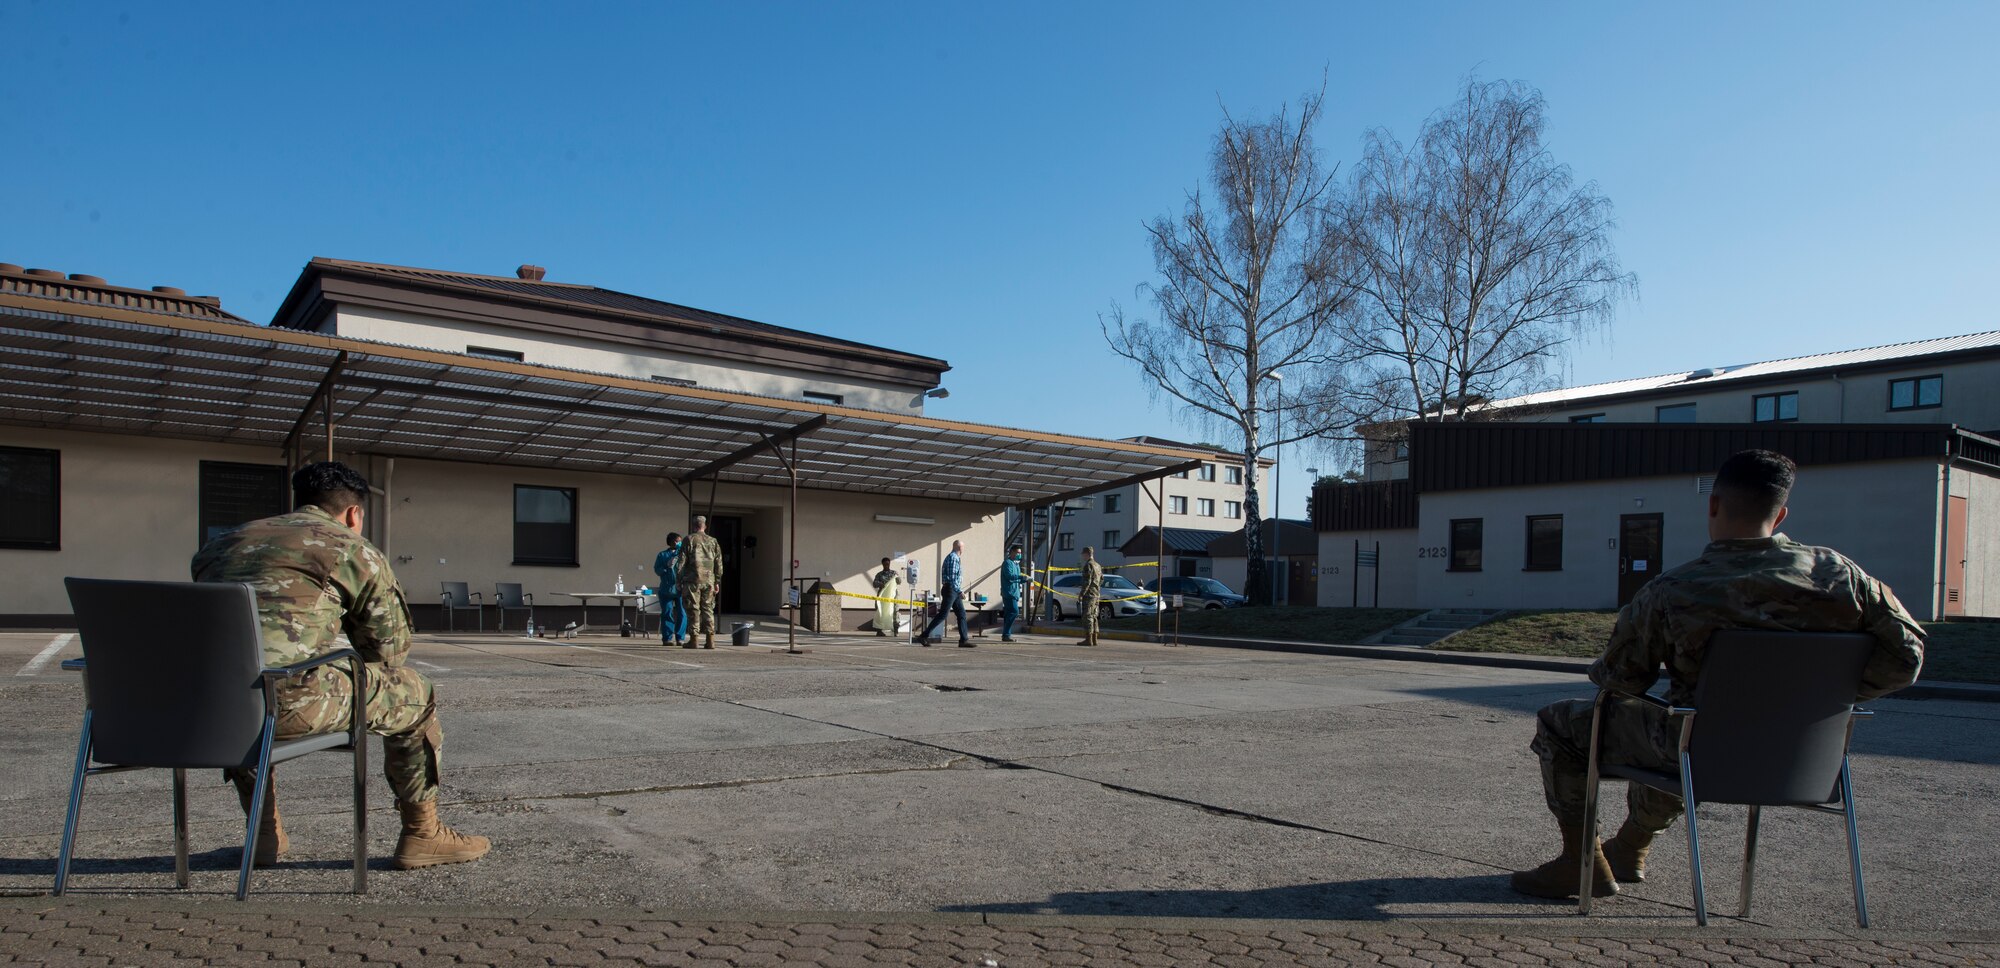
[56,578,368,900]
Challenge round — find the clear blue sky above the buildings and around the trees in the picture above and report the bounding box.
[0,0,2000,516]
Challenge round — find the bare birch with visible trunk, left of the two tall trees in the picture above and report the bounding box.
[1098,94,1346,602]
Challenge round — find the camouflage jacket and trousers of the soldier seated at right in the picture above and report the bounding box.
[1530,534,1924,832]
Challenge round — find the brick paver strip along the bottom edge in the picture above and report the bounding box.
[0,898,2000,968]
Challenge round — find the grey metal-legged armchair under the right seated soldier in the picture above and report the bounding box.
[1578,630,1876,928]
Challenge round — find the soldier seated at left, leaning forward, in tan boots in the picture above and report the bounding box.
[190,462,490,870]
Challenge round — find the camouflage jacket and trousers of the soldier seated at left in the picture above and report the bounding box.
[190,506,444,802]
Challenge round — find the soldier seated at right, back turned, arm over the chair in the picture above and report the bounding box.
[1514,450,1924,898]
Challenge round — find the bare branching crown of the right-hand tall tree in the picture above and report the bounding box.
[1340,80,1636,434]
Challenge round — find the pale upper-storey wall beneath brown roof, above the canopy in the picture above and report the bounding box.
[332,306,924,414]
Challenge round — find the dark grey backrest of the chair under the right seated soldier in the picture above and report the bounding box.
[1688,630,1876,806]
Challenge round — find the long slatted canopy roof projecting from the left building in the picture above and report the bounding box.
[0,298,1212,506]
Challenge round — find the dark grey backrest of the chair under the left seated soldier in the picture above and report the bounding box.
[64,578,264,768]
